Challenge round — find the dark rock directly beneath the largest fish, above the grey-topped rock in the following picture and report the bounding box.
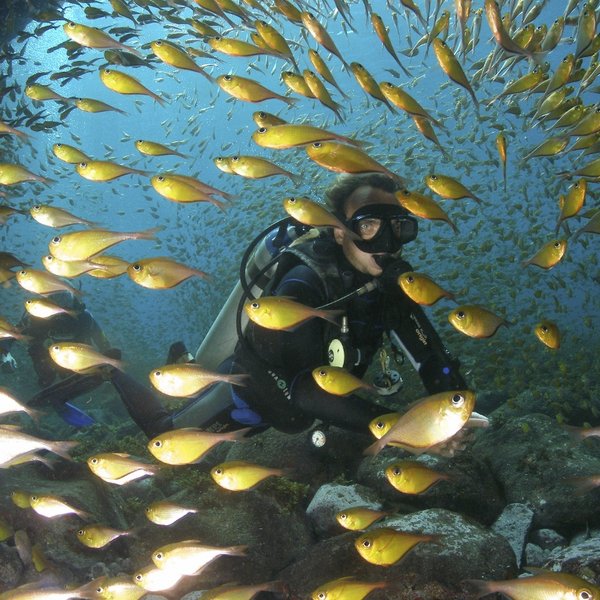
[357,447,504,525]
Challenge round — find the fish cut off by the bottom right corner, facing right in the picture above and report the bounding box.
[466,569,600,600]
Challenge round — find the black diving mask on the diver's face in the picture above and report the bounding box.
[347,204,418,254]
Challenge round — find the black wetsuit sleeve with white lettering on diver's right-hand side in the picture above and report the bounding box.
[385,278,467,394]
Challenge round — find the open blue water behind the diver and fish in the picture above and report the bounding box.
[0,1,600,404]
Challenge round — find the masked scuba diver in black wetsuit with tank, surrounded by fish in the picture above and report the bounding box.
[24,174,485,445]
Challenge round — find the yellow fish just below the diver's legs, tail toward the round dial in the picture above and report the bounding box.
[148,427,249,465]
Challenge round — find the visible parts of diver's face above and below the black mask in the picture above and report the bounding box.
[333,185,398,277]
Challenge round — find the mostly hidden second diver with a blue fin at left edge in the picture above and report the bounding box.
[0,292,112,427]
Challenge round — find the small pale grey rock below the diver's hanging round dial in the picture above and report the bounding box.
[306,483,381,537]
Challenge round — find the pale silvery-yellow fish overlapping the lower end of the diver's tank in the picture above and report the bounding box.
[150,363,248,398]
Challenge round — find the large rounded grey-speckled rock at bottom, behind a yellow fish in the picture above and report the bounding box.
[277,509,517,600]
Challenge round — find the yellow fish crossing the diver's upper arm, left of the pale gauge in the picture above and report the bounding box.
[244,296,342,330]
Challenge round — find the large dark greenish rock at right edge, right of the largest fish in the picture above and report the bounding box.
[472,414,600,533]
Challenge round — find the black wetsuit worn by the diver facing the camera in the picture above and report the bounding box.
[227,236,467,432]
